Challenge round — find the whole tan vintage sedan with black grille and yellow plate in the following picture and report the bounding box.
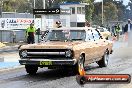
[19,27,113,74]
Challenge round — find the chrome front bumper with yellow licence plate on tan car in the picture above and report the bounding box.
[19,59,77,66]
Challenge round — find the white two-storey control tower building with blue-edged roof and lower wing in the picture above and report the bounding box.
[41,2,88,30]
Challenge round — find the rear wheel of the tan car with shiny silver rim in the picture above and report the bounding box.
[97,51,109,67]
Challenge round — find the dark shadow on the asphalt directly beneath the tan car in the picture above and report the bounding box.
[25,65,99,81]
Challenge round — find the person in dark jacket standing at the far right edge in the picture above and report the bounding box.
[124,19,132,46]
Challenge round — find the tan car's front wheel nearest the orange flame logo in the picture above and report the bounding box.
[73,55,85,75]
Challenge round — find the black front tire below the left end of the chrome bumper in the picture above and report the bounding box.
[25,65,38,75]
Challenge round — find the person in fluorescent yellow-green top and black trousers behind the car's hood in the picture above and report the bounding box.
[26,23,36,44]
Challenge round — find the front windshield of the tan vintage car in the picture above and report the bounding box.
[45,30,86,41]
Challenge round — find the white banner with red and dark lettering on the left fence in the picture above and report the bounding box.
[0,18,41,29]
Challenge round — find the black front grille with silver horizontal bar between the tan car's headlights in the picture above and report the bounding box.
[24,49,72,59]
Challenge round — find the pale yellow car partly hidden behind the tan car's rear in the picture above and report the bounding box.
[97,27,111,40]
